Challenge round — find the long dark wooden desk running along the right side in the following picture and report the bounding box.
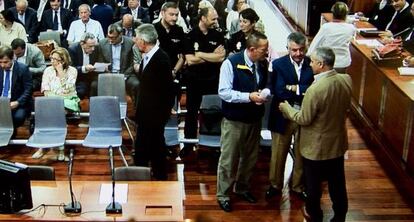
[322,13,414,199]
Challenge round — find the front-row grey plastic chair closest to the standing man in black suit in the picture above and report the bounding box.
[82,96,128,166]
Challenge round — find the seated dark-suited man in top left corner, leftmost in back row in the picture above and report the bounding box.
[9,0,39,43]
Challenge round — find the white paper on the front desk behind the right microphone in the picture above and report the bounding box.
[99,183,128,204]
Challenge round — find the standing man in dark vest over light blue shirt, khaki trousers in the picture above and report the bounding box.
[217,32,268,212]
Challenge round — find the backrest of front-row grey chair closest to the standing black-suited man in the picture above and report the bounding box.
[89,96,122,130]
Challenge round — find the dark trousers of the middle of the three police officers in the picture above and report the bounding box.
[184,80,218,138]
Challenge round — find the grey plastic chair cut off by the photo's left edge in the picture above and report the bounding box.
[0,97,13,147]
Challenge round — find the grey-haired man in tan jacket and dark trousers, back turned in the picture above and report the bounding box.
[279,48,352,221]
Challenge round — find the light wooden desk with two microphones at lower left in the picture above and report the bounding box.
[0,181,184,221]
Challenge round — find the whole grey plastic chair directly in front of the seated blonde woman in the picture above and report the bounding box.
[26,97,67,148]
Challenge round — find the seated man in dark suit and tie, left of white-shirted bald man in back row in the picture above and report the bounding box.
[40,0,73,47]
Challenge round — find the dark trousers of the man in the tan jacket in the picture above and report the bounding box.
[303,156,348,221]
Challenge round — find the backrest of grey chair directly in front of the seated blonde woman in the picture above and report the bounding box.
[35,96,66,131]
